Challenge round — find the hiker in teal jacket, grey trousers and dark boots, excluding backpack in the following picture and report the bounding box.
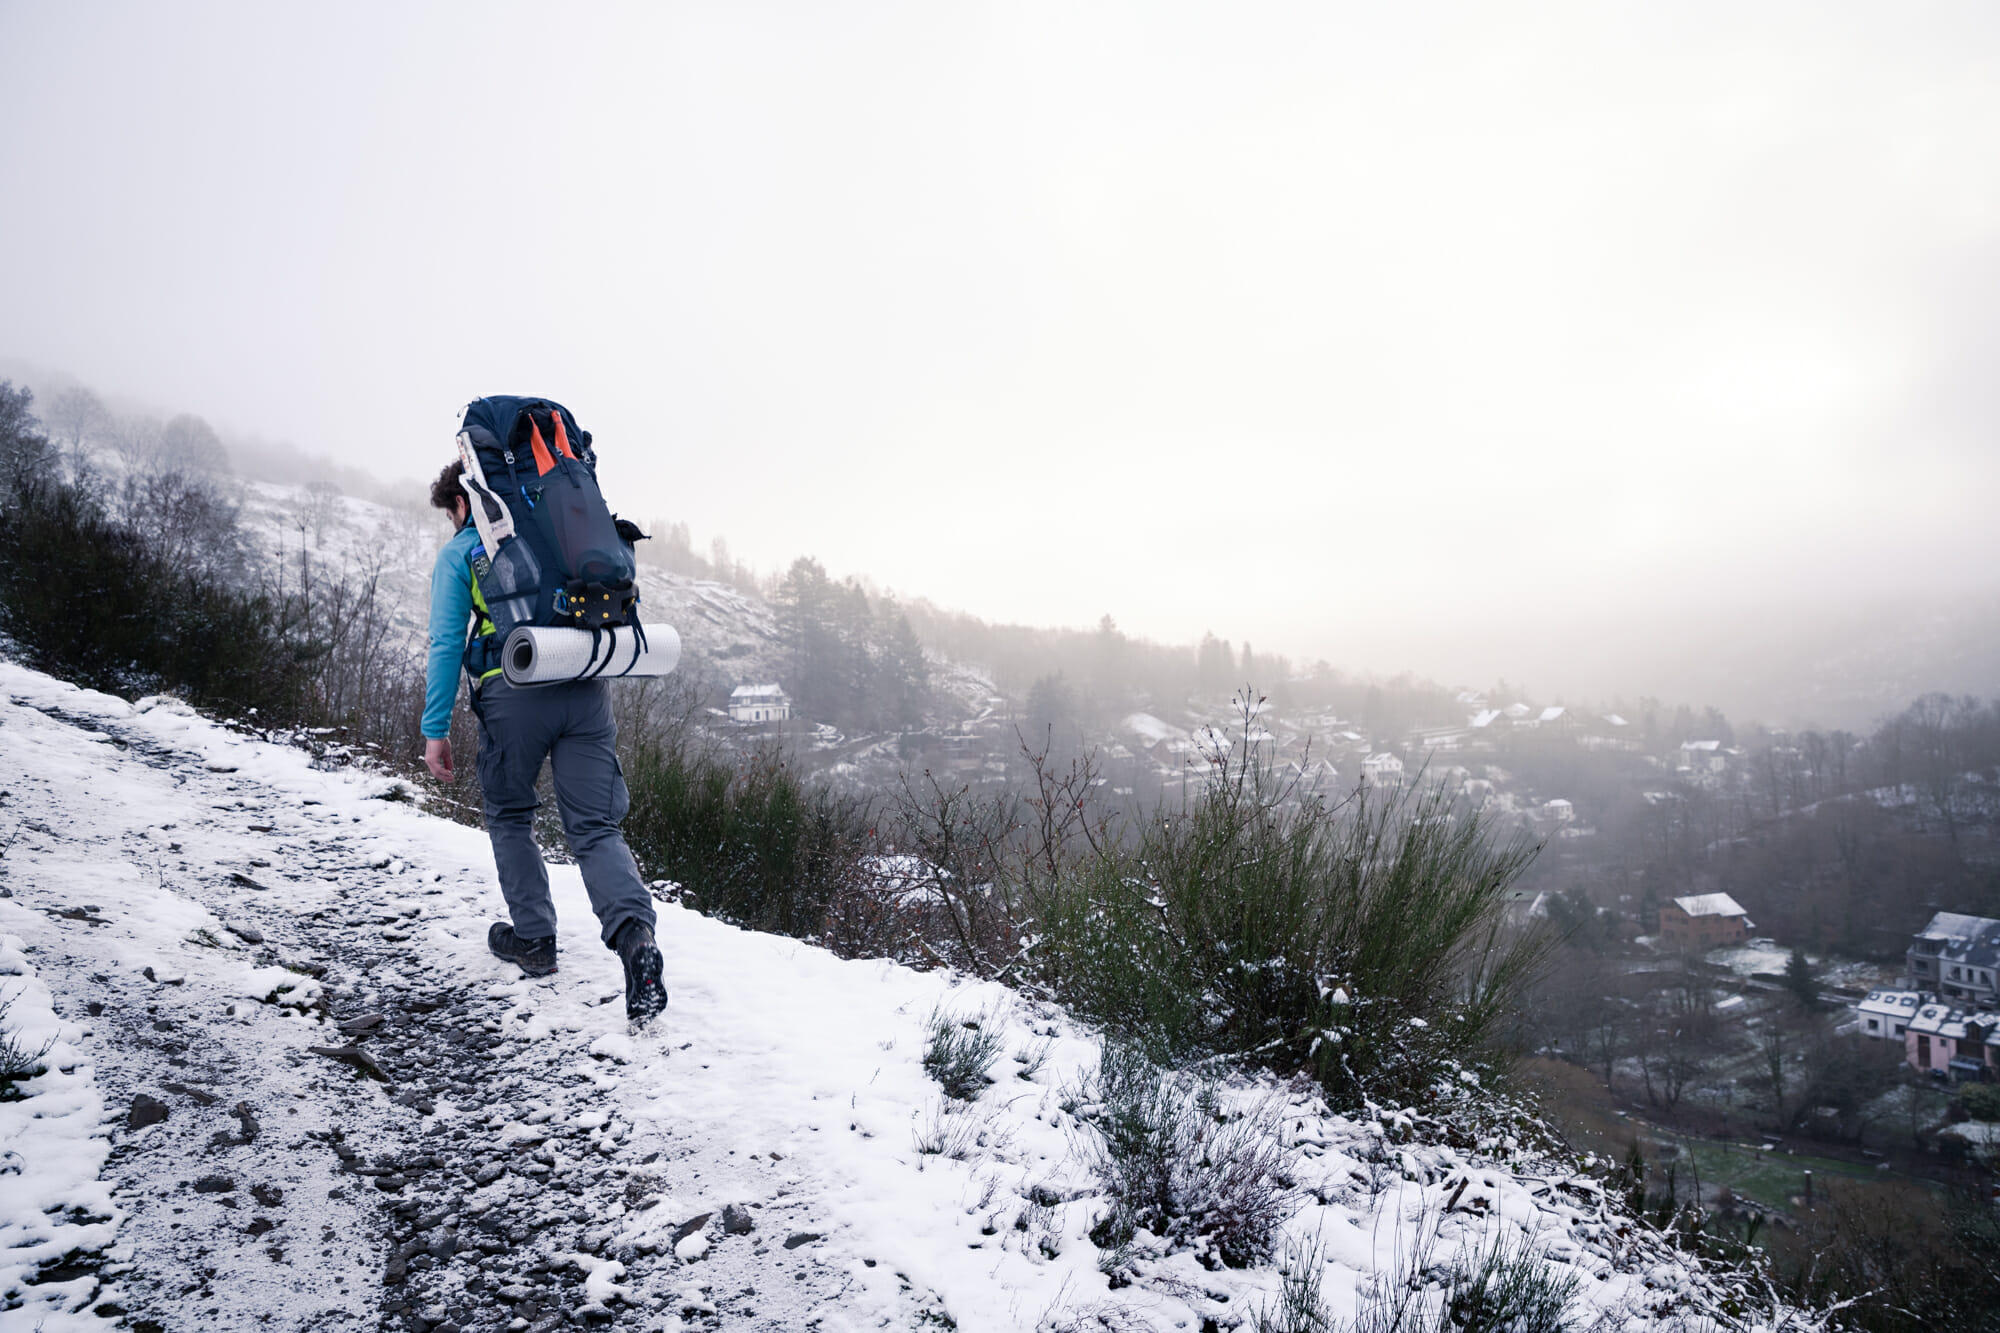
[424,458,666,1023]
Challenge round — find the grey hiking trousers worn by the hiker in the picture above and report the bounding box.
[474,677,654,945]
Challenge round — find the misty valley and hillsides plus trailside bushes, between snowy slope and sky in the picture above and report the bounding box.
[0,376,2000,1329]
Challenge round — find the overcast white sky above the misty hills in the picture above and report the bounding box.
[0,0,2000,689]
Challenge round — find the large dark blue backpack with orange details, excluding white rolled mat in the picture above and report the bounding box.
[458,396,642,679]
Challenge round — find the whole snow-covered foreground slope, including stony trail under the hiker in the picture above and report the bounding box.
[0,662,1784,1333]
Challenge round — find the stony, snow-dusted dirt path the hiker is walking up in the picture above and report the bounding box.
[0,676,968,1331]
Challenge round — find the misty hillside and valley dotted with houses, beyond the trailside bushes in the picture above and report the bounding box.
[35,456,2000,1280]
